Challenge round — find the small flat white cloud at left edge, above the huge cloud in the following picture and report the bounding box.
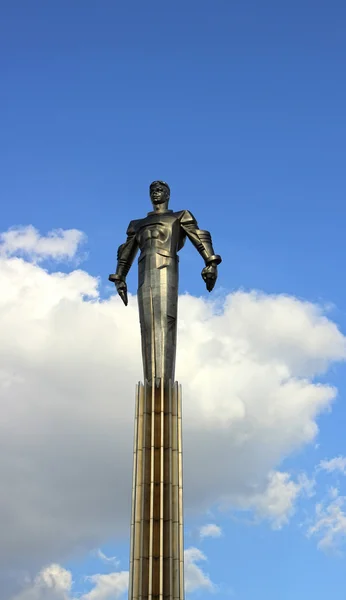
[0,225,85,261]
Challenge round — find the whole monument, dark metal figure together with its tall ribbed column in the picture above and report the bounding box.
[109,181,221,600]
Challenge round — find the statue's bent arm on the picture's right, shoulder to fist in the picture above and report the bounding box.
[180,210,222,292]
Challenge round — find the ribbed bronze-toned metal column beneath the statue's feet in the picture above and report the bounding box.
[129,383,184,600]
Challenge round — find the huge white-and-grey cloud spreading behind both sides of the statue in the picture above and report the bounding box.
[0,227,346,600]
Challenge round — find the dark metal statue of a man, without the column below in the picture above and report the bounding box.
[109,181,221,385]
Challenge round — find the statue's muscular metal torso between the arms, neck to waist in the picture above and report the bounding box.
[133,211,186,258]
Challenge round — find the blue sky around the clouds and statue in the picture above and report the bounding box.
[0,0,346,600]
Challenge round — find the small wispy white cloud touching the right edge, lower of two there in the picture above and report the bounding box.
[307,488,346,551]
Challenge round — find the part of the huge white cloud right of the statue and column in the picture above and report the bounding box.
[178,292,345,520]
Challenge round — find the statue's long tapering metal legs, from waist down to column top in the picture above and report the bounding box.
[138,254,178,383]
